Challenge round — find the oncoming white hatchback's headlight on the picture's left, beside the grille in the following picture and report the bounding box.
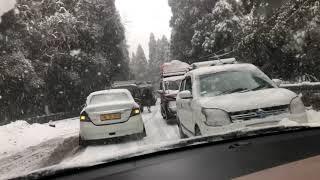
[202,108,231,126]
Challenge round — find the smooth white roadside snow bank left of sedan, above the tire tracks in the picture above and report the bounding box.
[0,118,79,156]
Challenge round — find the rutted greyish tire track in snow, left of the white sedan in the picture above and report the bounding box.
[0,136,78,179]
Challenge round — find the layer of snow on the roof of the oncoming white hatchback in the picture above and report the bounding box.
[186,63,259,76]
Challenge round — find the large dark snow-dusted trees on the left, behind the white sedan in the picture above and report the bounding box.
[0,0,129,119]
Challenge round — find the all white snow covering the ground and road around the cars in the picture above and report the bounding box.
[0,101,320,179]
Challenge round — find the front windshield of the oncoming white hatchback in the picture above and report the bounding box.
[199,71,273,97]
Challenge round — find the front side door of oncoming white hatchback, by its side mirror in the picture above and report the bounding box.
[180,76,194,132]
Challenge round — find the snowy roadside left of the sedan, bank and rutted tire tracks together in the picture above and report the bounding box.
[0,118,79,179]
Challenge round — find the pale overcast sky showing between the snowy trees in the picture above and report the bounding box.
[116,0,171,58]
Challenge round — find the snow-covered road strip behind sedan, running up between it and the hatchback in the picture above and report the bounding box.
[63,102,180,164]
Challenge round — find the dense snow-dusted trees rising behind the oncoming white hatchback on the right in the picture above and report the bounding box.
[169,0,320,80]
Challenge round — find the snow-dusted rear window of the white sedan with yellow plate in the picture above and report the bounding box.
[90,93,129,105]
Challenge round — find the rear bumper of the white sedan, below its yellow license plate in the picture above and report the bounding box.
[80,115,144,140]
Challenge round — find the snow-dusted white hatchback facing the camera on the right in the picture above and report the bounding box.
[177,64,307,137]
